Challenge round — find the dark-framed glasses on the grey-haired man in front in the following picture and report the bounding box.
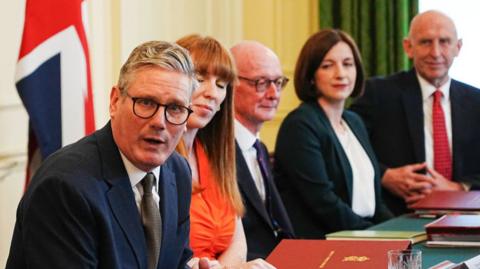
[127,93,193,125]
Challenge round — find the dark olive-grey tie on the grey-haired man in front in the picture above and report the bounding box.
[142,173,162,269]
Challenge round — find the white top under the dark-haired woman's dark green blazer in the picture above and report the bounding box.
[335,120,375,217]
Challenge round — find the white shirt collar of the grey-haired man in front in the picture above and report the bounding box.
[120,152,160,211]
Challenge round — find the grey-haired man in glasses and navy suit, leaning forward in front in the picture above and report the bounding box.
[6,41,202,269]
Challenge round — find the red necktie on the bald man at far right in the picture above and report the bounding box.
[432,90,452,180]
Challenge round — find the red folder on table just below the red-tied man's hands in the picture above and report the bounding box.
[410,188,480,212]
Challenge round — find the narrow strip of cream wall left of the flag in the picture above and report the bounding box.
[0,0,28,267]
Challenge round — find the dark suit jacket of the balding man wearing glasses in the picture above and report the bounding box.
[236,140,293,260]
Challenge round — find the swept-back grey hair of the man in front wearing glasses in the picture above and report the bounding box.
[117,41,198,95]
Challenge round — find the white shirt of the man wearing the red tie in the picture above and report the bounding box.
[417,74,452,168]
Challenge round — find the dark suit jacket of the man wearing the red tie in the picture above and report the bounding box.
[351,69,480,215]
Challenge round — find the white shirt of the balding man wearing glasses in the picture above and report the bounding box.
[235,120,265,203]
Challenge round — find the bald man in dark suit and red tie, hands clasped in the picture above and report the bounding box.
[351,11,480,215]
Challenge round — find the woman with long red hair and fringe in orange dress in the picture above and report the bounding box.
[177,35,274,269]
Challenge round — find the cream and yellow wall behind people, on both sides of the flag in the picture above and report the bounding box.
[0,0,318,267]
